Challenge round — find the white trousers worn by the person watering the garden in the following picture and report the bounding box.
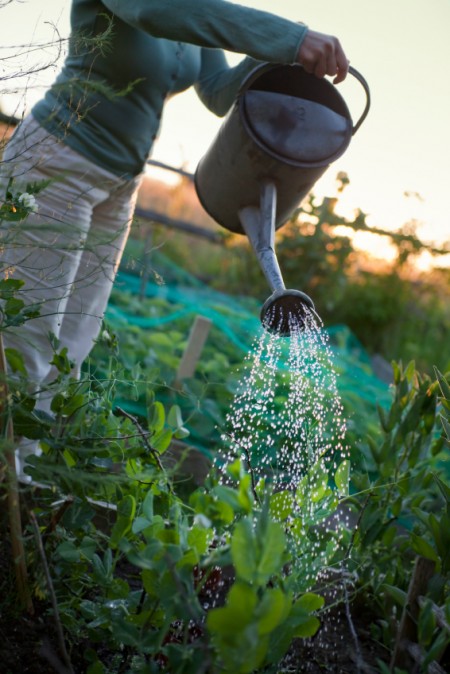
[0,116,141,462]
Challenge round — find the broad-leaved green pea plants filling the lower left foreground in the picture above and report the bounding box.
[0,332,334,674]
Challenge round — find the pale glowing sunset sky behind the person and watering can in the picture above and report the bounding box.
[0,0,450,262]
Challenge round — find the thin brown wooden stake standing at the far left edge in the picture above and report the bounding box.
[0,332,33,613]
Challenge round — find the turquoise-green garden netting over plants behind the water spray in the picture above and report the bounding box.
[94,251,391,468]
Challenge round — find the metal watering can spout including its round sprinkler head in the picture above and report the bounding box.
[239,181,314,337]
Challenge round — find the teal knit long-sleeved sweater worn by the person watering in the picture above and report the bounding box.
[32,0,307,177]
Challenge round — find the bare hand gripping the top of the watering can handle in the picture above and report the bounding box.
[297,30,349,84]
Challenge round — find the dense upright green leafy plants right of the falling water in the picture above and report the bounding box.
[349,363,450,671]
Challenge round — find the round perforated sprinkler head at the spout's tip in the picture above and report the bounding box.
[261,290,315,337]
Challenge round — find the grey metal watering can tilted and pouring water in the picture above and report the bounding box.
[195,63,370,336]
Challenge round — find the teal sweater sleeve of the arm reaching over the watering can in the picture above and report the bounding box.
[102,0,307,63]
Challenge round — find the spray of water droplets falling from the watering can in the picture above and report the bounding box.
[216,308,349,589]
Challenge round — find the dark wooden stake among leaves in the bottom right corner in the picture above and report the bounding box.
[391,556,435,671]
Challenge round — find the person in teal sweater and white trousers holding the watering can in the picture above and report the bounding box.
[0,0,349,468]
